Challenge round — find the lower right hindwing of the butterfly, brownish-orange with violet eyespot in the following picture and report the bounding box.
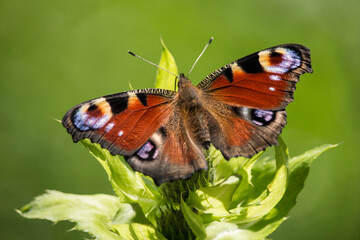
[208,104,286,159]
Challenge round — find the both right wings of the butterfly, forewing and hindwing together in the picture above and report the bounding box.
[198,44,312,158]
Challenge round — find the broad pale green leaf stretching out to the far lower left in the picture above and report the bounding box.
[17,190,124,240]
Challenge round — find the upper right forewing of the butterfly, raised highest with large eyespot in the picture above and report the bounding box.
[198,44,312,110]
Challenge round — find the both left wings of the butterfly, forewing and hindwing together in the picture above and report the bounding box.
[62,89,207,184]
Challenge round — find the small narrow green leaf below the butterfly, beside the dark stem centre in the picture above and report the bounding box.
[181,198,206,239]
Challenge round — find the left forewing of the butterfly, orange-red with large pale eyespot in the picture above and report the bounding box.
[62,89,176,155]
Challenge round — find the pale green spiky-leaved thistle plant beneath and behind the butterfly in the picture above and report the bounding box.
[17,41,336,240]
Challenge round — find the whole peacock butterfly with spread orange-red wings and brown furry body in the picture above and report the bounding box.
[62,44,312,185]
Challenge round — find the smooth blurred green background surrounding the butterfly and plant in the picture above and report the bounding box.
[0,0,360,239]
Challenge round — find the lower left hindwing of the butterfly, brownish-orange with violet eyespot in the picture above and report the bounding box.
[125,124,207,185]
